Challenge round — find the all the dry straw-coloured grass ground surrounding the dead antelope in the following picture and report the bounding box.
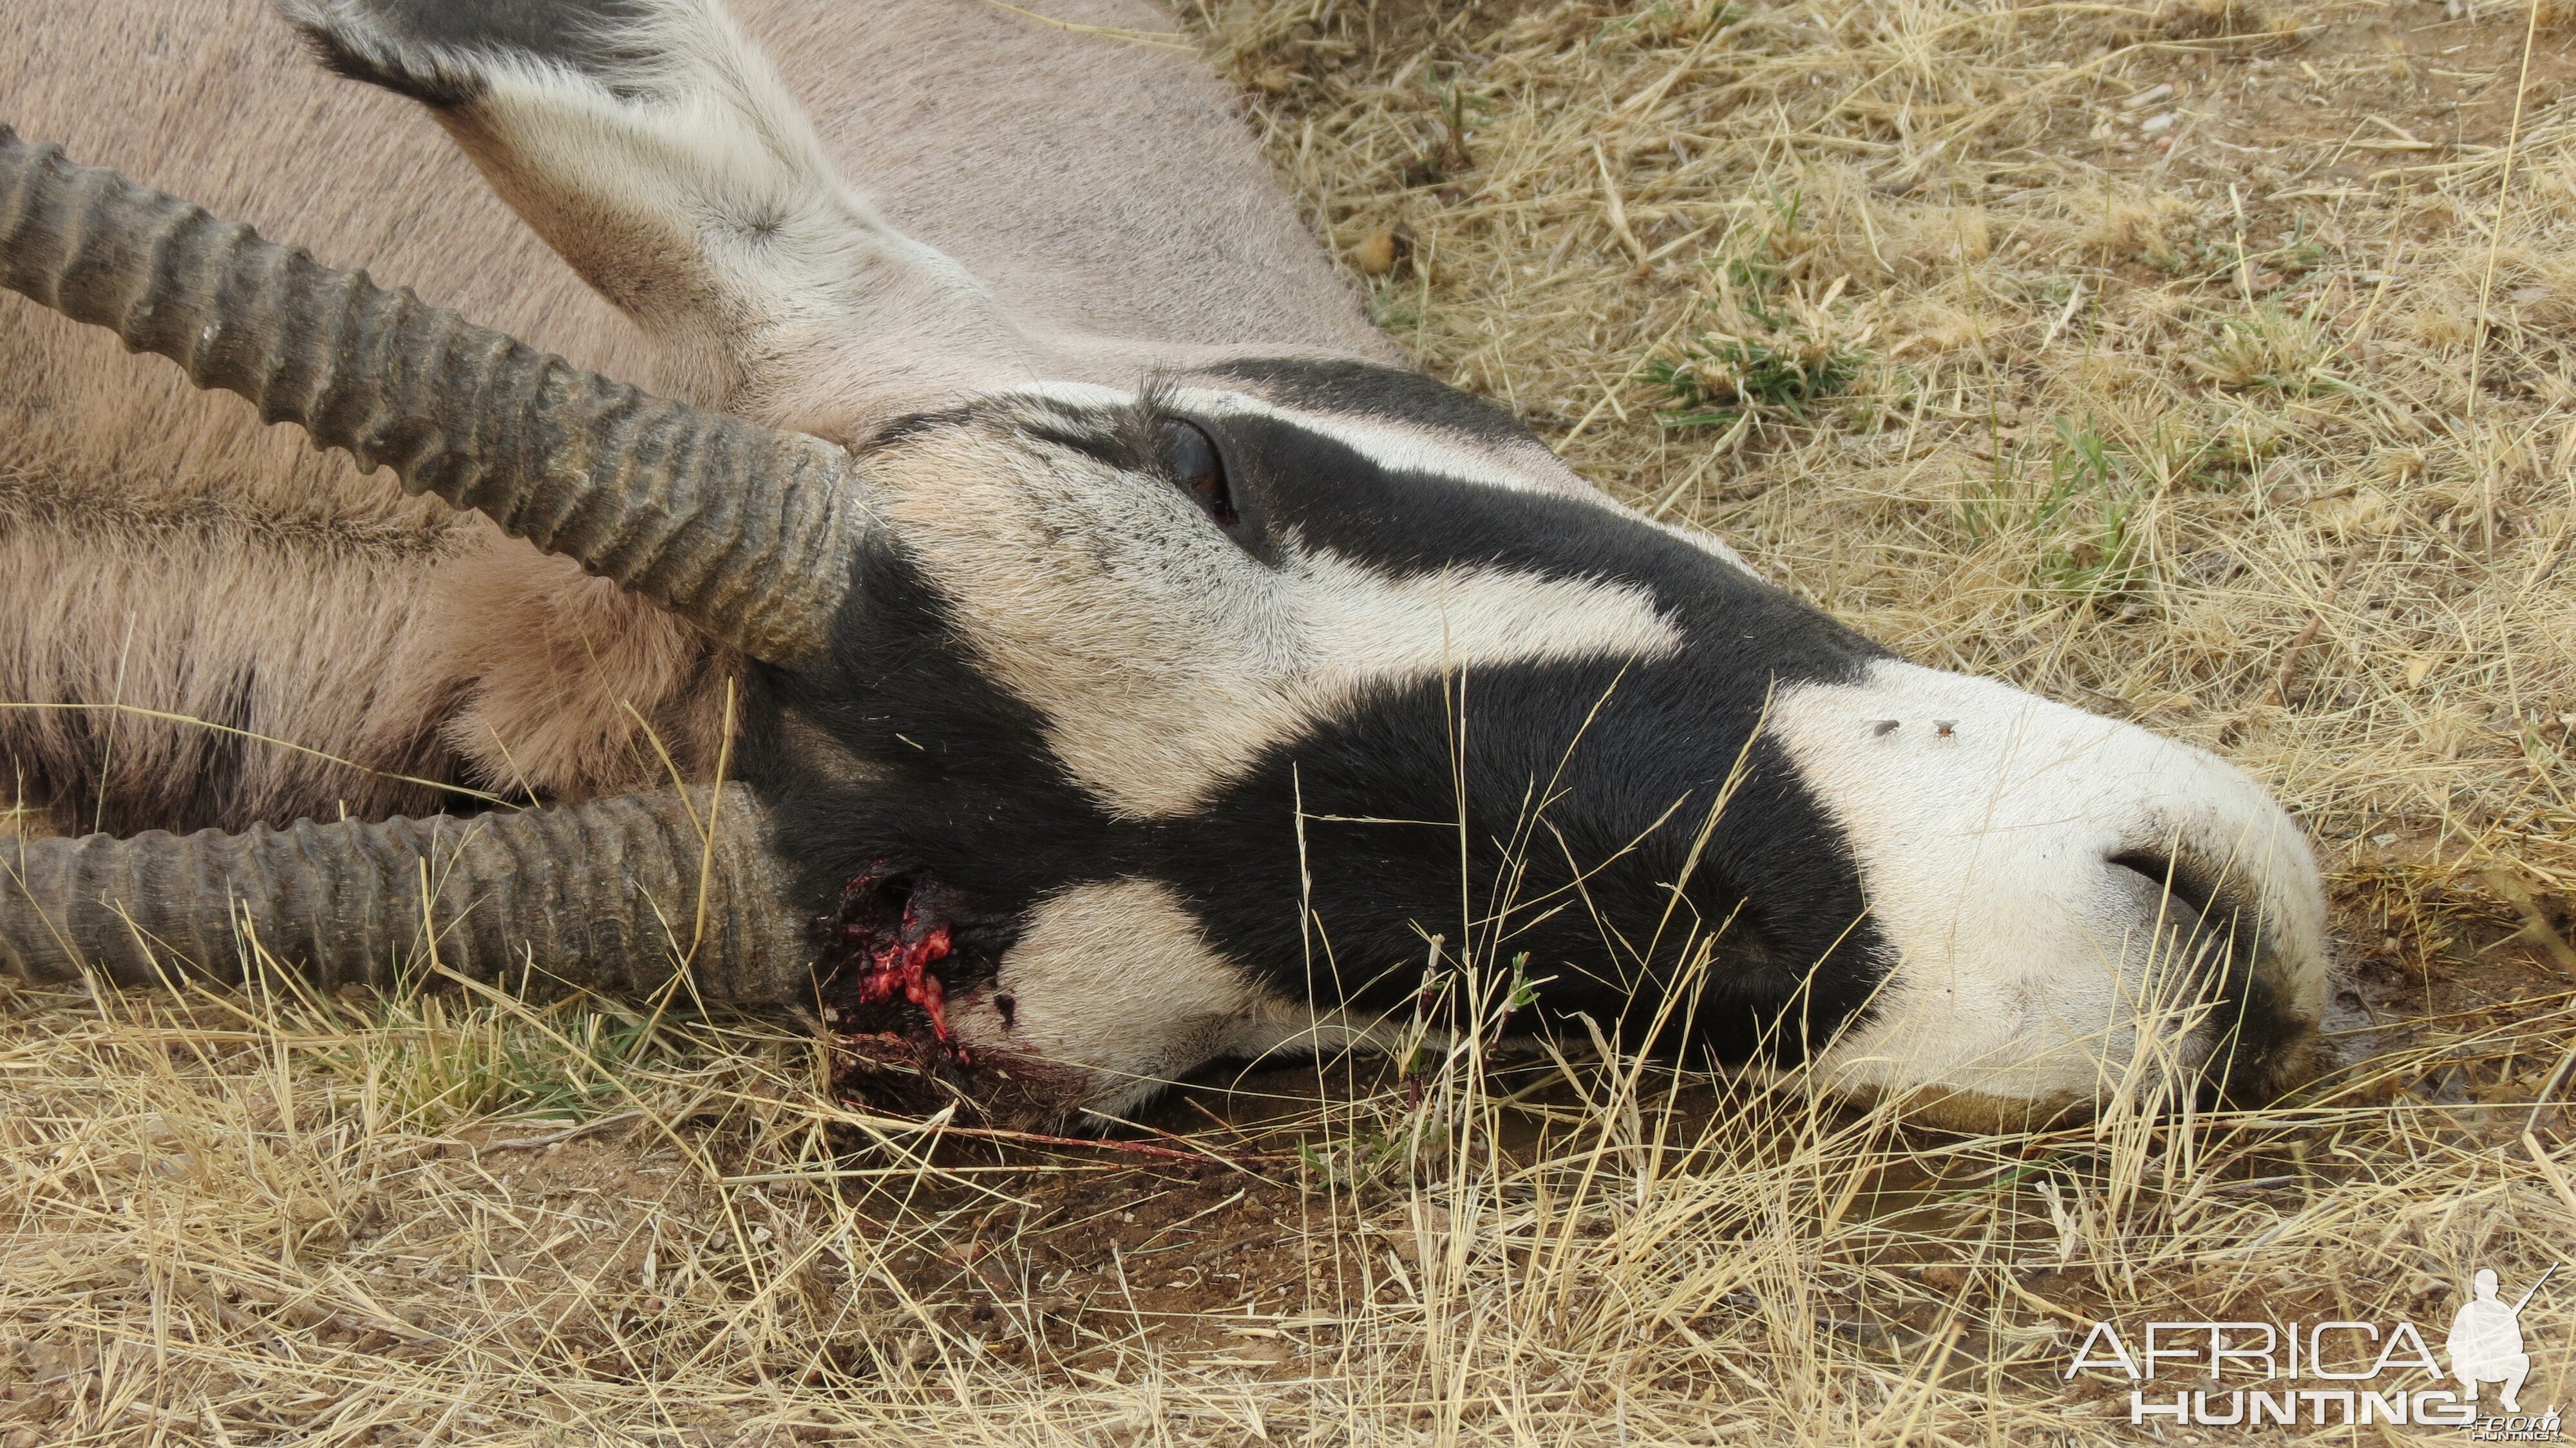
[0,0,2576,1448]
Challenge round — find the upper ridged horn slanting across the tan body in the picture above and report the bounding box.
[0,124,868,662]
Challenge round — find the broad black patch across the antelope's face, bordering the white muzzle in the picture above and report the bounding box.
[1154,657,1888,1059]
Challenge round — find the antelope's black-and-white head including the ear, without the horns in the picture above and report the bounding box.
[261,0,2324,1113]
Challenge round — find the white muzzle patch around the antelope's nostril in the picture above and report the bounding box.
[1770,662,2326,1103]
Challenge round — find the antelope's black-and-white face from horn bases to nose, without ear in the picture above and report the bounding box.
[762,363,2316,1110]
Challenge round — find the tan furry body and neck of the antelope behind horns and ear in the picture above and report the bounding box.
[0,0,1388,832]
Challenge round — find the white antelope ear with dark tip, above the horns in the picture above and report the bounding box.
[278,0,1025,407]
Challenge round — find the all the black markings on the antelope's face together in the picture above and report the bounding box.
[755,368,1888,1059]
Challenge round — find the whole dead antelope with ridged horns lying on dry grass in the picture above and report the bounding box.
[0,0,2324,1118]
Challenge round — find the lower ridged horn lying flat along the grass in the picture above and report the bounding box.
[0,783,811,1005]
